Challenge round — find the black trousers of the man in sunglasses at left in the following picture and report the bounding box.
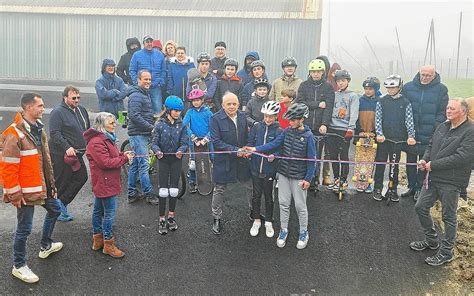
[51,153,87,206]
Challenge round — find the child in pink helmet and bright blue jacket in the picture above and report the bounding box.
[183,89,212,193]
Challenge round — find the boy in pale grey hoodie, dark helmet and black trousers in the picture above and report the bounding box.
[327,70,359,191]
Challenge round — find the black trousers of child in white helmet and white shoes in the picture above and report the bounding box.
[250,173,275,222]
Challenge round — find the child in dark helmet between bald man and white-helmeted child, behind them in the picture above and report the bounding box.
[245,78,270,128]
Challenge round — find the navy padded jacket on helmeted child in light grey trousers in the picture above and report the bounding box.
[255,125,317,182]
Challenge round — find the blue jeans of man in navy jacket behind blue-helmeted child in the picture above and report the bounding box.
[128,135,153,196]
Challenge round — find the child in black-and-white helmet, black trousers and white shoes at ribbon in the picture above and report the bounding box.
[247,101,282,237]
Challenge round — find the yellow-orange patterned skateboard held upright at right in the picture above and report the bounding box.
[352,133,377,191]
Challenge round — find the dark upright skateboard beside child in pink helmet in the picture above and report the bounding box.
[194,144,214,195]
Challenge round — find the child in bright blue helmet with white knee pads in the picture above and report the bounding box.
[151,96,189,235]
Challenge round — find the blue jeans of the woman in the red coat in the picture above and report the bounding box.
[92,196,117,240]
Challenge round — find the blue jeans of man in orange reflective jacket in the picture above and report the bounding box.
[13,198,61,268]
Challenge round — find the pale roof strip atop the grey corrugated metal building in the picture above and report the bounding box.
[0,0,322,19]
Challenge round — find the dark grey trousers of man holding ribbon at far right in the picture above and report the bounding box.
[415,182,460,256]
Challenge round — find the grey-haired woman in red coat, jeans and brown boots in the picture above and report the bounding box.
[84,112,133,258]
